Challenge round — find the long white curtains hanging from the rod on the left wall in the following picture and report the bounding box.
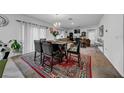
[21,23,47,54]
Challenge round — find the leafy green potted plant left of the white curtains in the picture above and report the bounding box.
[9,40,22,53]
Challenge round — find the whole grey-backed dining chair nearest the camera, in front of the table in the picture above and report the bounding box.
[42,42,62,71]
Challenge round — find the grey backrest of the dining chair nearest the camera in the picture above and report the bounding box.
[42,42,53,56]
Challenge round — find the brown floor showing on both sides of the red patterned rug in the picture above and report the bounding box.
[9,48,121,78]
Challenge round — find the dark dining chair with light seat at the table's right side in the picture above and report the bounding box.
[67,39,80,66]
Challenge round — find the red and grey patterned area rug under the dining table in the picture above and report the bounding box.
[21,52,92,78]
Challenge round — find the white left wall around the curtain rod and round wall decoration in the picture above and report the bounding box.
[0,14,49,42]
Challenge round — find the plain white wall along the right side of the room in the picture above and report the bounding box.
[100,14,124,76]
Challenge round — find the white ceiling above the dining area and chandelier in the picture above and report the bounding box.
[26,14,103,28]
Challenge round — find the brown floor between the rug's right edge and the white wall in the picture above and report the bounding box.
[81,48,121,78]
